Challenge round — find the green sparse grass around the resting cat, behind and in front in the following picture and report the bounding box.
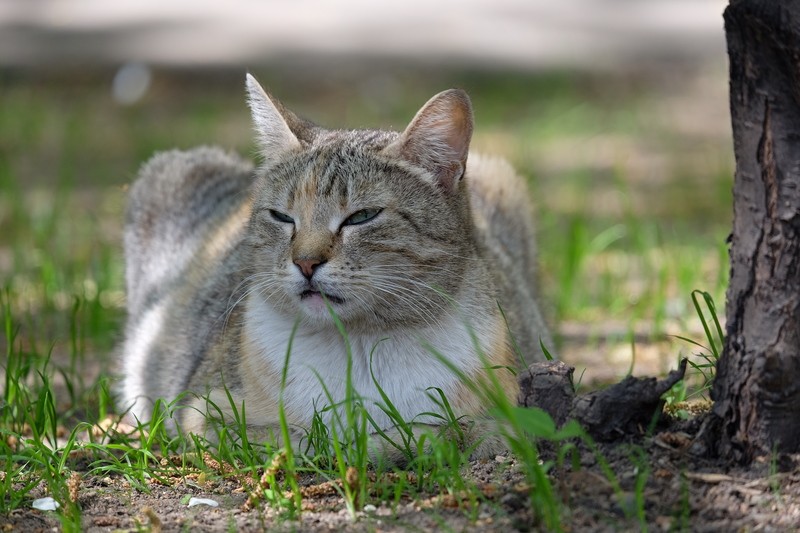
[0,65,732,530]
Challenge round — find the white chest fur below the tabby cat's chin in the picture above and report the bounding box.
[245,295,495,428]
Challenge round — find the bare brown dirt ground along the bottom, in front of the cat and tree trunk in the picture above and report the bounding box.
[6,417,800,532]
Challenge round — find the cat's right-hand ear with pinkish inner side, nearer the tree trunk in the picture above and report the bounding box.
[384,89,473,192]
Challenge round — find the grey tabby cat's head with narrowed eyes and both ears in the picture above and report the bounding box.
[247,71,476,328]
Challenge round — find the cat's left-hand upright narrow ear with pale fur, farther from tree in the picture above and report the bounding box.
[247,73,302,165]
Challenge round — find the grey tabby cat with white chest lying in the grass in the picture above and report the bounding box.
[121,74,550,457]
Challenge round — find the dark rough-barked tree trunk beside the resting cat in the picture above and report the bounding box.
[712,0,800,462]
